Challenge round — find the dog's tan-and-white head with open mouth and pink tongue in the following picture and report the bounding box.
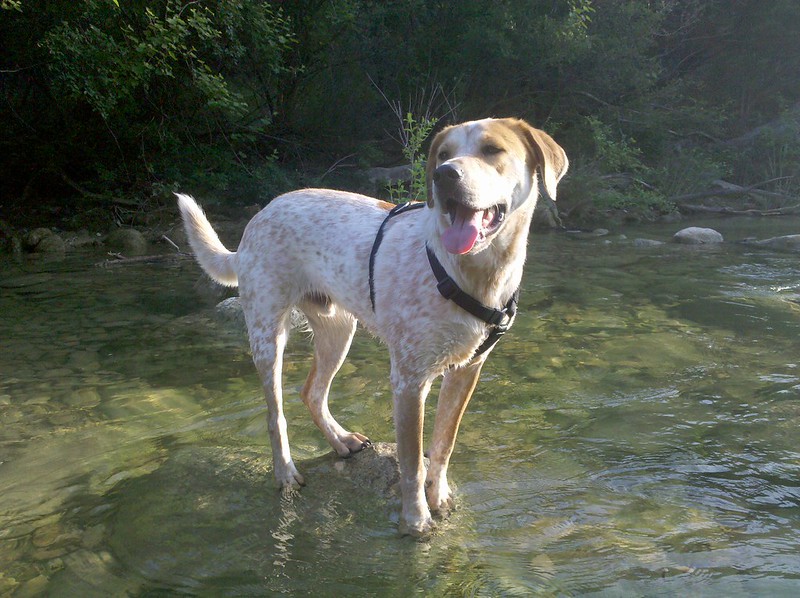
[427,118,569,254]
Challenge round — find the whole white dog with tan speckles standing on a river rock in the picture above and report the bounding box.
[178,118,569,536]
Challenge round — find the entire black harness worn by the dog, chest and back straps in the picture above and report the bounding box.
[369,203,519,359]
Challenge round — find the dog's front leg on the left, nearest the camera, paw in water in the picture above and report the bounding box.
[392,367,433,536]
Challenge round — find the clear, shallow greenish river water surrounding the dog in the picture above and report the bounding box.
[0,219,800,596]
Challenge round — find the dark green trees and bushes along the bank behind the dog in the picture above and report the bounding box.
[0,0,800,224]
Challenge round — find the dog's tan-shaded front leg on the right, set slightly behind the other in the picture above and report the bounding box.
[425,359,484,513]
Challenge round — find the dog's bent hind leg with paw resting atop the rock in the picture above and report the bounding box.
[300,300,370,457]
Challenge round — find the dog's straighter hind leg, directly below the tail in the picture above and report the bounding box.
[245,310,305,490]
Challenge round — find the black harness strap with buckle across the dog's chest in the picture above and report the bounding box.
[425,244,519,359]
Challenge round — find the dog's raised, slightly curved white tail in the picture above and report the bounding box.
[175,193,238,287]
